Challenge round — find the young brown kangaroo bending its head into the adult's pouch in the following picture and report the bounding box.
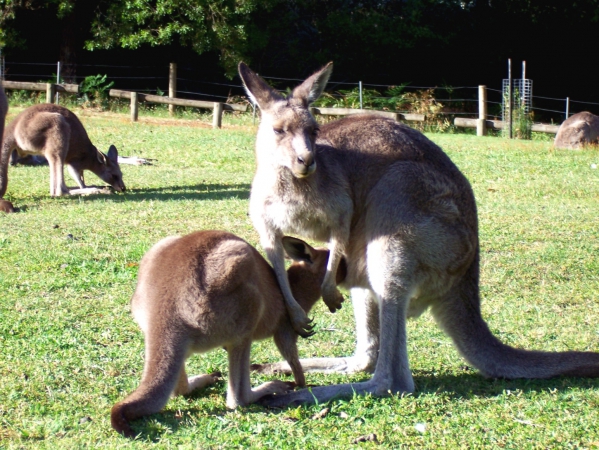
[111,231,345,437]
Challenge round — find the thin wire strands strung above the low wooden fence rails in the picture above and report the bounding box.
[0,60,599,123]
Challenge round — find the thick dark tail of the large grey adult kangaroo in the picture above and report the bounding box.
[432,259,599,378]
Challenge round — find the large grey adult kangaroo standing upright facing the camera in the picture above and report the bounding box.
[239,63,599,406]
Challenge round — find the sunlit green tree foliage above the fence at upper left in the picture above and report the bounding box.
[0,0,278,75]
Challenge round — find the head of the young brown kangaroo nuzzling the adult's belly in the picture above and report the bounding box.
[283,236,347,312]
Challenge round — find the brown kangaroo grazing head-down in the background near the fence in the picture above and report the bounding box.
[0,103,125,198]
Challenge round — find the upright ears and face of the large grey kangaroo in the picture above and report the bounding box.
[239,63,333,178]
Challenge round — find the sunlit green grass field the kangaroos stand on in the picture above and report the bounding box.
[0,108,599,448]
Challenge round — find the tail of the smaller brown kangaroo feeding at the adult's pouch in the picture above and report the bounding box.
[110,336,186,438]
